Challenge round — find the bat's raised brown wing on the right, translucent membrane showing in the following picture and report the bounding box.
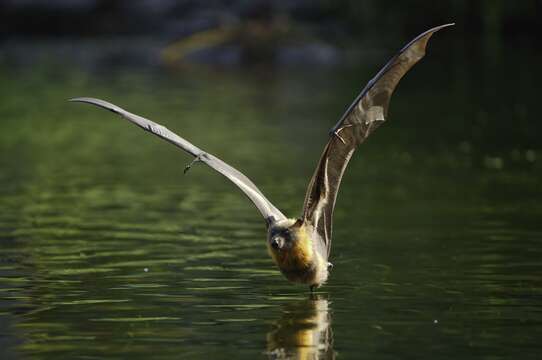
[303,24,453,254]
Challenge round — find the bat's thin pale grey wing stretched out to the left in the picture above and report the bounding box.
[70,97,286,225]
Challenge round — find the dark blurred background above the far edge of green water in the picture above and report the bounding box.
[0,0,542,65]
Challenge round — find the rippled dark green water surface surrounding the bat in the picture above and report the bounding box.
[0,39,542,359]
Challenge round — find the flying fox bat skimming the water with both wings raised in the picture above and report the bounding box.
[70,24,453,291]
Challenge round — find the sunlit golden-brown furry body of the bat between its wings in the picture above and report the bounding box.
[267,219,328,286]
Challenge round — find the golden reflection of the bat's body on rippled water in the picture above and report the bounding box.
[267,295,335,359]
